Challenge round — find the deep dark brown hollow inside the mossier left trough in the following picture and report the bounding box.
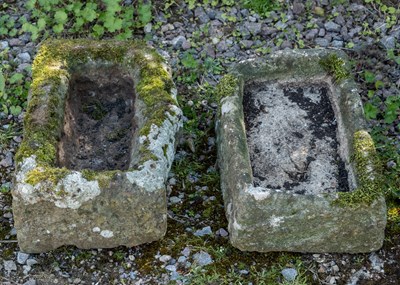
[58,66,137,170]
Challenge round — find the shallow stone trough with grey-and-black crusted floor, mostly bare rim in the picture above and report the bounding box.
[216,50,386,253]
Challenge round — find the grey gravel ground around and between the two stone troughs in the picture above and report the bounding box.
[0,0,400,285]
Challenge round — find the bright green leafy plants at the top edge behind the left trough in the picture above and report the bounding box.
[22,0,152,40]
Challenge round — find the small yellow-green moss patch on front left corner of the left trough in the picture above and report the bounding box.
[25,167,71,185]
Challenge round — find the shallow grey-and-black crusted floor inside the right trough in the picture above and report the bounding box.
[243,82,349,195]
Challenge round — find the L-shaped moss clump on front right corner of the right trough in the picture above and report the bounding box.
[334,130,383,207]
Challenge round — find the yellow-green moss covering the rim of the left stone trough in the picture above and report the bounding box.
[16,39,178,188]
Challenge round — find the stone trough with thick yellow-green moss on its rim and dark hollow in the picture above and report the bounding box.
[12,40,181,253]
